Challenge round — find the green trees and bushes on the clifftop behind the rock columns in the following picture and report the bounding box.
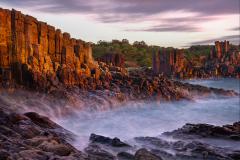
[93,39,236,67]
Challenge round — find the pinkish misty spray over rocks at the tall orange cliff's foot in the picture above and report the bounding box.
[0,89,127,120]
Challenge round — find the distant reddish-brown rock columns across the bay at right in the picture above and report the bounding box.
[152,41,240,78]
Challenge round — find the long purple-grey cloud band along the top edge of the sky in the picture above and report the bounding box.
[1,0,238,17]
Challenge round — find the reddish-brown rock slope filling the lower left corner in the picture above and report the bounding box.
[0,108,86,160]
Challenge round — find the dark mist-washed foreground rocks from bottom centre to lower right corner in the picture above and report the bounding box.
[87,122,240,160]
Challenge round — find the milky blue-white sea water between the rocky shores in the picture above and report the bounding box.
[57,79,240,148]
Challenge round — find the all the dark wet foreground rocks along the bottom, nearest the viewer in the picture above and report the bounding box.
[0,106,240,160]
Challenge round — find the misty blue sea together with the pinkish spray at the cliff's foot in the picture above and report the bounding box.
[0,79,239,148]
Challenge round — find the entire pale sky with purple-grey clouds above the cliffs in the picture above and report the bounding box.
[0,0,240,47]
